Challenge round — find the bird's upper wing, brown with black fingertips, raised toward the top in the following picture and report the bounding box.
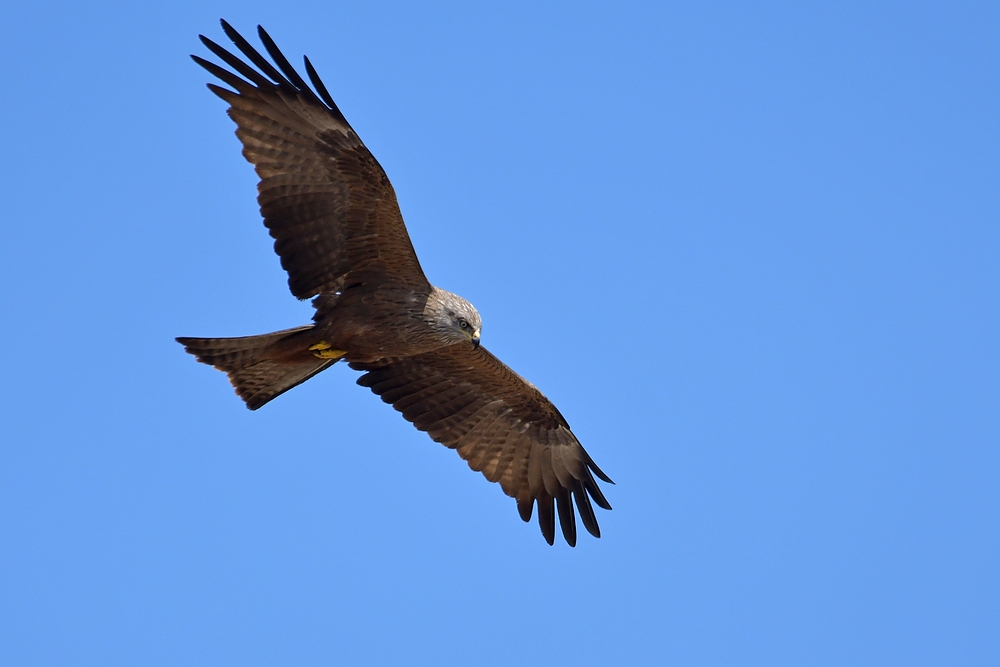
[191,21,430,299]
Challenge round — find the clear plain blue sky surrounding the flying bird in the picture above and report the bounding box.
[0,0,1000,666]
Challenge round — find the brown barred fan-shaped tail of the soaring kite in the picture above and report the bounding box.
[177,325,338,410]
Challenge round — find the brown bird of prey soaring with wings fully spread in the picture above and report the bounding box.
[177,21,613,546]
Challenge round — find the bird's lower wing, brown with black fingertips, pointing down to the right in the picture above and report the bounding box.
[351,343,613,546]
